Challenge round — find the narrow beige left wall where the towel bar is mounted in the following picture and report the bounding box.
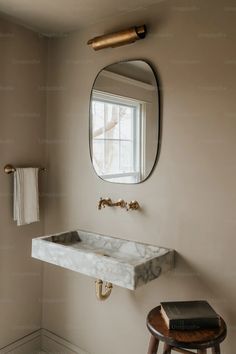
[0,20,46,347]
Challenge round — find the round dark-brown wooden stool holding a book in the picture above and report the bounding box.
[147,306,227,354]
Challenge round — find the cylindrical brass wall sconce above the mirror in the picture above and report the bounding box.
[87,25,147,50]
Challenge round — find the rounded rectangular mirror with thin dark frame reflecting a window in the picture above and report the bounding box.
[90,60,160,183]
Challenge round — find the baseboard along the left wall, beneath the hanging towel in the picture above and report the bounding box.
[0,330,41,354]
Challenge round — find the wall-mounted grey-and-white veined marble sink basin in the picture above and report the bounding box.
[32,230,174,290]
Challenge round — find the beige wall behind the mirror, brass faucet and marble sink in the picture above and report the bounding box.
[42,0,236,354]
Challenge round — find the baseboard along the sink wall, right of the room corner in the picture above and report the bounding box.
[40,329,88,354]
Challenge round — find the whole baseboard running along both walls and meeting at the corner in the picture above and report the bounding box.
[0,329,88,354]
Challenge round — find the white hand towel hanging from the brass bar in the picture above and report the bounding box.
[14,167,39,226]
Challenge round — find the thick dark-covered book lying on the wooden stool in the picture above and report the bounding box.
[161,301,220,331]
